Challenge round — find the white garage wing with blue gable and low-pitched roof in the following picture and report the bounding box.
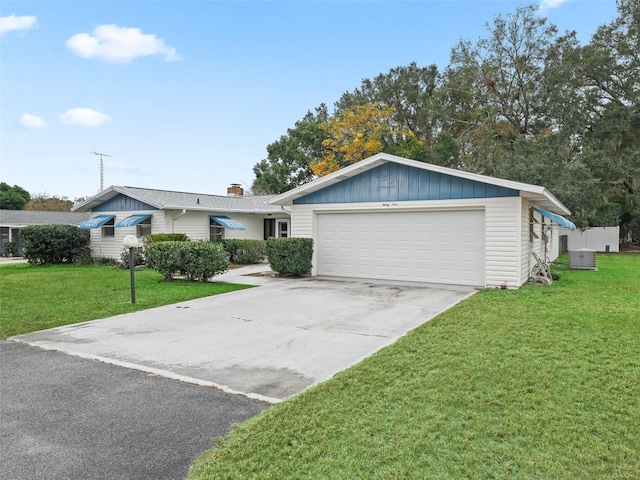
[269,153,575,288]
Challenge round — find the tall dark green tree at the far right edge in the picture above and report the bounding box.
[545,0,640,226]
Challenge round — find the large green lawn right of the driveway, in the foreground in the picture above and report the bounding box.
[189,254,640,480]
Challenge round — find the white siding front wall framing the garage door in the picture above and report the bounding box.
[291,197,523,288]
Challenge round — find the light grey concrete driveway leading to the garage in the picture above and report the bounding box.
[12,265,474,402]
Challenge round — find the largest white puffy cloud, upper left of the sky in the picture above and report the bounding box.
[67,25,181,63]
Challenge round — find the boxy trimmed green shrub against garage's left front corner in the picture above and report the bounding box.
[266,238,313,275]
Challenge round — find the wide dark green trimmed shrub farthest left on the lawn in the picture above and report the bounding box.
[20,225,89,265]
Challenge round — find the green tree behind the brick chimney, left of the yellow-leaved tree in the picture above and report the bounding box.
[251,104,329,195]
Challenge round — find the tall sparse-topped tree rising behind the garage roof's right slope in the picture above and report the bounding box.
[443,5,557,175]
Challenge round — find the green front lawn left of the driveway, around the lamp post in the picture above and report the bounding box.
[0,263,248,338]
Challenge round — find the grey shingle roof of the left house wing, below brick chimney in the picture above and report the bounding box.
[73,186,283,213]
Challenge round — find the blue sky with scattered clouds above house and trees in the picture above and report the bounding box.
[0,0,616,200]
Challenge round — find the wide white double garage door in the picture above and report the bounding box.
[316,210,485,286]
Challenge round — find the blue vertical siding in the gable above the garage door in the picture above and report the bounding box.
[293,162,520,205]
